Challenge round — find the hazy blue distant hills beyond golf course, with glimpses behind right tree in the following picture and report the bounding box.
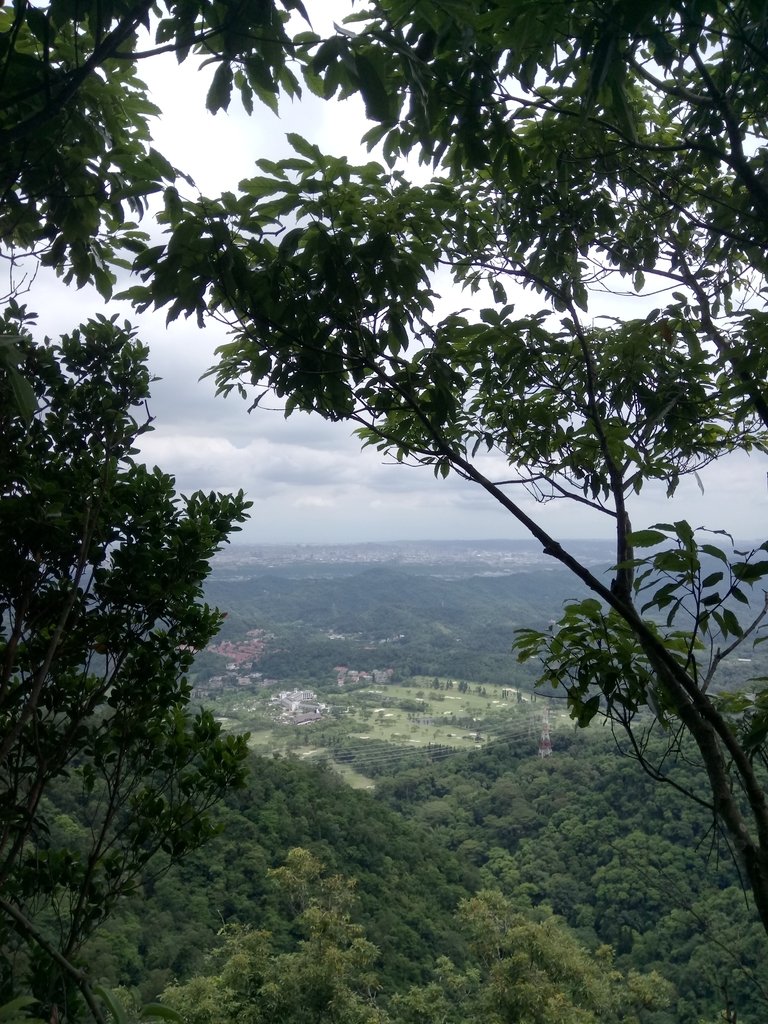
[196,542,768,688]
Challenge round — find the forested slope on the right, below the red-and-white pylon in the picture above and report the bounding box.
[377,725,768,1024]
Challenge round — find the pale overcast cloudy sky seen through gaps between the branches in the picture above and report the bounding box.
[27,0,768,543]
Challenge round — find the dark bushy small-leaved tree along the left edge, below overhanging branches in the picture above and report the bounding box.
[0,302,248,1019]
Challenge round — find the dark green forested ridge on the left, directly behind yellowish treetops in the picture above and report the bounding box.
[83,757,479,1000]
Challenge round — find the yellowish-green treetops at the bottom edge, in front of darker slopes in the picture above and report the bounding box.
[163,850,667,1024]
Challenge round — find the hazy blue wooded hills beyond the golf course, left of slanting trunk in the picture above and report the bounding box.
[207,563,589,684]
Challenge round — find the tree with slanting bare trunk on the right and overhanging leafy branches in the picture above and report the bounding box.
[123,0,768,928]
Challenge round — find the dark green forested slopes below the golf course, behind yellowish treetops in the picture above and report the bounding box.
[78,729,768,1024]
